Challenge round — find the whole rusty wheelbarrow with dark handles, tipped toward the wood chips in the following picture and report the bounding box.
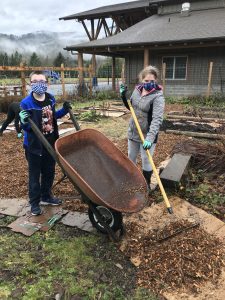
[26,110,147,240]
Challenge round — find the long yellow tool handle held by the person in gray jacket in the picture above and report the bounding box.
[127,100,173,214]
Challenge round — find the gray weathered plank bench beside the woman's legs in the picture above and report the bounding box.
[160,153,191,187]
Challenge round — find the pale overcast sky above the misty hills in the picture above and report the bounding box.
[0,0,134,35]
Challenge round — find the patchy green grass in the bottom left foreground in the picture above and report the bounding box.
[0,217,157,300]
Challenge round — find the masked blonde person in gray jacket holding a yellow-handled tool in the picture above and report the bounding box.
[120,66,165,190]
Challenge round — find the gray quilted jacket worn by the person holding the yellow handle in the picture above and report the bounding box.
[128,89,165,143]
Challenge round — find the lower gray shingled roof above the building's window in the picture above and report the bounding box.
[62,8,225,54]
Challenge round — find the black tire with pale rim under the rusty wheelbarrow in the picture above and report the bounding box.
[88,205,123,233]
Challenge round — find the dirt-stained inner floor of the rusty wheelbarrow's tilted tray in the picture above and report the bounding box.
[65,145,147,212]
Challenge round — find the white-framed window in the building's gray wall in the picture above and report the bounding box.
[163,56,187,79]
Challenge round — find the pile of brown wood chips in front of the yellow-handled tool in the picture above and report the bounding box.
[123,220,225,293]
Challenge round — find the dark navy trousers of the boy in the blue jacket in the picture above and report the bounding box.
[25,149,55,206]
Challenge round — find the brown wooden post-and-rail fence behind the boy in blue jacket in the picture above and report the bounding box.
[0,63,93,99]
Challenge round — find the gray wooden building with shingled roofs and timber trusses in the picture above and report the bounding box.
[59,0,225,96]
